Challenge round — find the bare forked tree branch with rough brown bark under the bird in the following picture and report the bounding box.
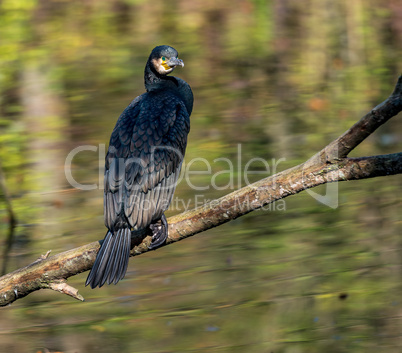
[0,76,402,306]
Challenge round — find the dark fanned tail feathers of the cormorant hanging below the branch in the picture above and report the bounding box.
[85,228,131,288]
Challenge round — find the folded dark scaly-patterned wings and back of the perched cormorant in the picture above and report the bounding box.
[104,90,189,231]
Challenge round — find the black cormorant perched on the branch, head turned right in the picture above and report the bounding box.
[85,45,193,288]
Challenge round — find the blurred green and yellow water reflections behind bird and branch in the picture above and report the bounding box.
[0,0,402,353]
